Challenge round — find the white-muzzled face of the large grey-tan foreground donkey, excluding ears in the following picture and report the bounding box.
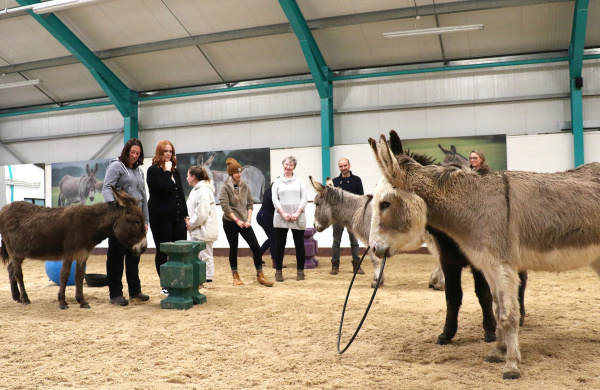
[369,177,427,257]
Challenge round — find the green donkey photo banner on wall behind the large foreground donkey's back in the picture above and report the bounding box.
[402,134,506,171]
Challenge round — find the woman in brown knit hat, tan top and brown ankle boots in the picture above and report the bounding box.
[219,158,273,287]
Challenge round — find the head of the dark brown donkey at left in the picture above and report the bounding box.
[111,187,148,256]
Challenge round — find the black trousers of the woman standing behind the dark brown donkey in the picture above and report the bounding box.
[106,237,142,298]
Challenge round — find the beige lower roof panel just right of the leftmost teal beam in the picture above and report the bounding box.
[105,46,222,91]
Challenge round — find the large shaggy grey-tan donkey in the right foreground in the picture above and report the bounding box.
[369,131,600,379]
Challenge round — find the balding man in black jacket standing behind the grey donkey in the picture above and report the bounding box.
[330,158,365,275]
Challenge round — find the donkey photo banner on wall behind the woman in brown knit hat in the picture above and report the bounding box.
[177,148,271,204]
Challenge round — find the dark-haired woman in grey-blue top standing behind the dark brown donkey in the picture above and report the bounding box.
[102,138,149,306]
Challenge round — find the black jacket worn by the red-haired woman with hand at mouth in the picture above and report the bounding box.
[146,165,188,223]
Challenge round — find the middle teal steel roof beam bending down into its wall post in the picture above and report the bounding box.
[279,0,334,180]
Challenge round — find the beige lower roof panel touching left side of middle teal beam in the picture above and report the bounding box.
[202,34,309,81]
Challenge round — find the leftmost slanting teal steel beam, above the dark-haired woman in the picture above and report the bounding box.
[17,0,138,140]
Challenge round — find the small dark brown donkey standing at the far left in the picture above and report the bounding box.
[0,188,147,309]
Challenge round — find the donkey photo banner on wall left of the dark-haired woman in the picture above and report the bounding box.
[52,159,110,207]
